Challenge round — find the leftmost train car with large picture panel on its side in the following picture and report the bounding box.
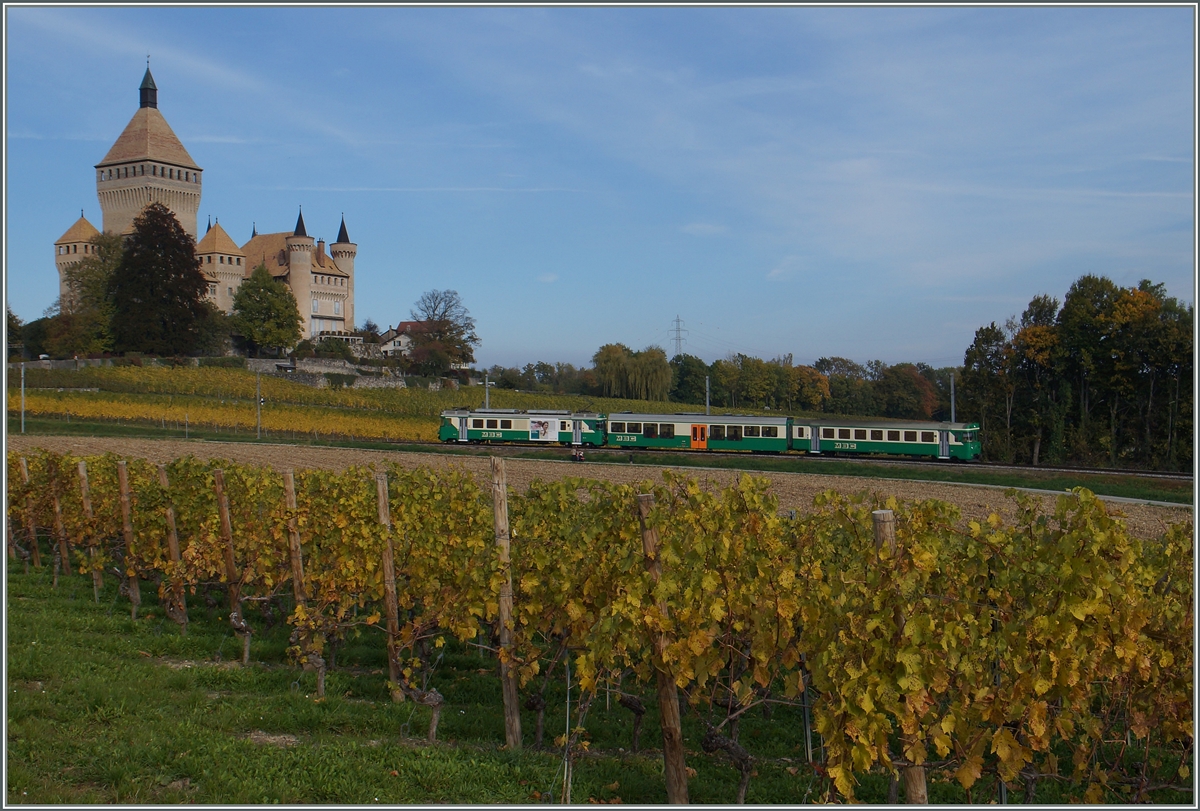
[438,408,604,447]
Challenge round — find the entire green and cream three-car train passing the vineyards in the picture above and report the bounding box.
[438,408,979,461]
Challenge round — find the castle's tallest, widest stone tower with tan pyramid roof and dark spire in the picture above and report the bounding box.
[96,65,203,239]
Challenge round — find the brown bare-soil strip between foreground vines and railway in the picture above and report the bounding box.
[8,434,1192,537]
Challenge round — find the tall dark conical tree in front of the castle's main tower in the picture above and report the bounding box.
[109,203,209,355]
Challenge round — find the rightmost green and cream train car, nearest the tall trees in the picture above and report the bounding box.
[791,417,979,461]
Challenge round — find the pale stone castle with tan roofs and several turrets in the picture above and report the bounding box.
[54,65,358,338]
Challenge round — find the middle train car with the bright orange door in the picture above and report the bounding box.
[607,411,791,453]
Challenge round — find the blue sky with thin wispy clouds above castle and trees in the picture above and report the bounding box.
[5,6,1195,366]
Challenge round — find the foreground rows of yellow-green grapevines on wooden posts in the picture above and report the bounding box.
[7,452,1194,803]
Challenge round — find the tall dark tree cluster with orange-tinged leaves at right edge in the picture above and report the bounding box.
[960,275,1194,470]
